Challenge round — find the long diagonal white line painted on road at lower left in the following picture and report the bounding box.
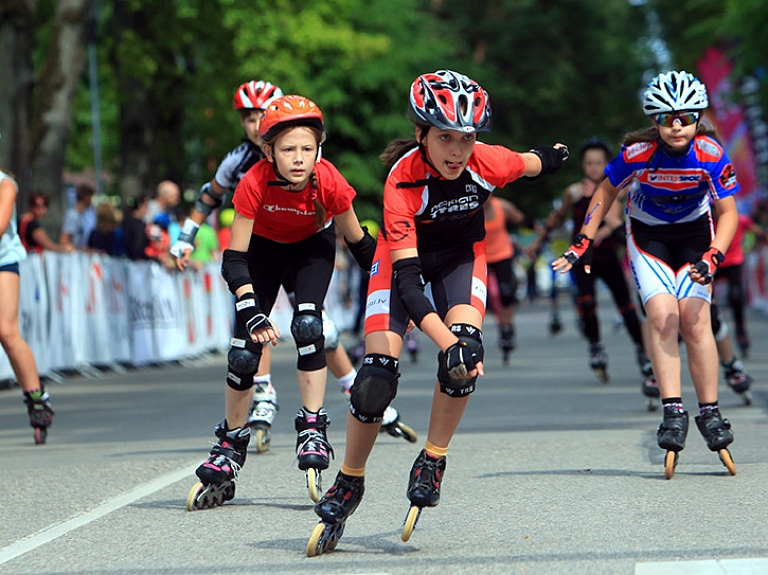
[0,465,197,565]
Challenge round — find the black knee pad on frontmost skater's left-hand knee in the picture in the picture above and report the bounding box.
[349,353,400,423]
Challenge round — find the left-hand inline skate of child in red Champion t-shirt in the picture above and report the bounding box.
[187,420,251,511]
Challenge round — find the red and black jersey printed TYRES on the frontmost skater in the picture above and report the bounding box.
[384,142,525,252]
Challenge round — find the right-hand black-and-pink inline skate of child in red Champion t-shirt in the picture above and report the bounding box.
[295,407,333,502]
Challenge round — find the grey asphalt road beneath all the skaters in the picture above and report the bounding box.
[0,296,768,575]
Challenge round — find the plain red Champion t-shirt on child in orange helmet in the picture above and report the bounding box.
[232,159,356,243]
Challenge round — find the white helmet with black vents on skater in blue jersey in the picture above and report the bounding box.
[643,71,709,116]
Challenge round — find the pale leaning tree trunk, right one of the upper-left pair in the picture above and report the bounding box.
[31,0,91,221]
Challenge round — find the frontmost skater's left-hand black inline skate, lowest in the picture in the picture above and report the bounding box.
[307,471,365,557]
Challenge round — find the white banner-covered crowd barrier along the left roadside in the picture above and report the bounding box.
[0,252,354,381]
